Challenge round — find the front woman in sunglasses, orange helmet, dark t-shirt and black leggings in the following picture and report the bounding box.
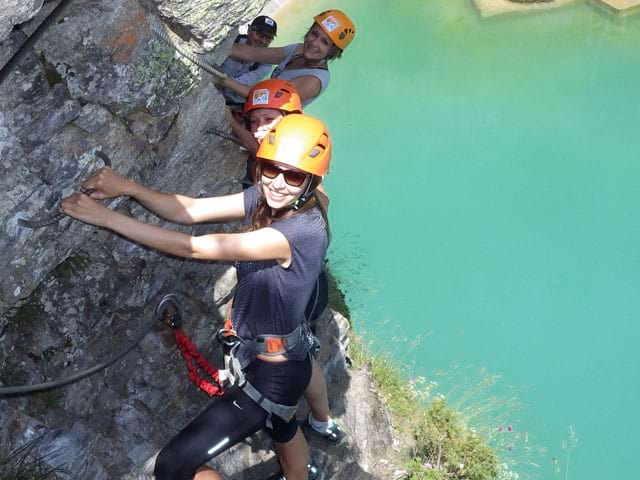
[61,114,331,480]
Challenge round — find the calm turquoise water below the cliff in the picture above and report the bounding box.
[277,0,640,480]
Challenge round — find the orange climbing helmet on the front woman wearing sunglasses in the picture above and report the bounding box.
[256,113,331,177]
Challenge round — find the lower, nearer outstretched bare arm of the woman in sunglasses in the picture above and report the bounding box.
[60,193,291,266]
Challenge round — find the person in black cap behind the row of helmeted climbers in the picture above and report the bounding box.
[221,15,278,109]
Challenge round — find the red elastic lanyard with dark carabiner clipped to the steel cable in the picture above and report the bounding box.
[155,293,224,397]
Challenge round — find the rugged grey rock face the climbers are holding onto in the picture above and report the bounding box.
[0,0,400,480]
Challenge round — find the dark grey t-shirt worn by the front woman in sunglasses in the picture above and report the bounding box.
[231,186,328,360]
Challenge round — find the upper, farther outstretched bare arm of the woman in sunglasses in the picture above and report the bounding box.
[82,167,244,225]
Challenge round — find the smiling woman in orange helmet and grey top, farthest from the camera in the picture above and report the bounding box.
[223,10,356,106]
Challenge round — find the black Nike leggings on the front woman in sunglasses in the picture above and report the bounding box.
[154,357,311,480]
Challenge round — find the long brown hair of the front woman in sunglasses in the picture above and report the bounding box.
[251,164,331,241]
